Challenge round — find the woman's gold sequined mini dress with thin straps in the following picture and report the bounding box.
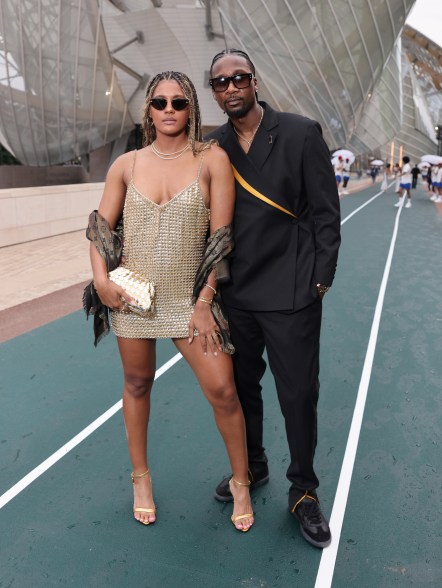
[111,152,210,339]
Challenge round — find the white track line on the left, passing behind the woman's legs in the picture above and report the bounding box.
[0,353,182,509]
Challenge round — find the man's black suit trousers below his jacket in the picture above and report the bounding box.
[227,298,322,505]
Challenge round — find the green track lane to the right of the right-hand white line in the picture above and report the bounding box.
[333,191,442,588]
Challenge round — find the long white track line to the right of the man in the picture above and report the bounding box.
[315,206,402,588]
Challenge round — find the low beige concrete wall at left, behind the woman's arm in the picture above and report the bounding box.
[0,182,104,247]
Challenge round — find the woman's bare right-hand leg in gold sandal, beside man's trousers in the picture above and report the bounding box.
[174,337,253,530]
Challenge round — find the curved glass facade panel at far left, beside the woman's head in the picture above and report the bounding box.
[0,0,133,166]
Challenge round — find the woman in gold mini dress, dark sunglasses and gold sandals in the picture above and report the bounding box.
[91,72,254,532]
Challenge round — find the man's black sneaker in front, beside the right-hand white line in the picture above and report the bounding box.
[290,492,331,547]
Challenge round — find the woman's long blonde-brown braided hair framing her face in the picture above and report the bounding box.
[141,71,202,155]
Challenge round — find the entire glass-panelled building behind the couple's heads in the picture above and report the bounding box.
[0,0,442,166]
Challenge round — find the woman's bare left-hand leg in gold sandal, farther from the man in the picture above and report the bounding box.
[118,337,155,524]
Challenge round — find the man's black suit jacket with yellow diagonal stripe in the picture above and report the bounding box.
[206,102,340,311]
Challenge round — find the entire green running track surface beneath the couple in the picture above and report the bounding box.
[0,183,442,588]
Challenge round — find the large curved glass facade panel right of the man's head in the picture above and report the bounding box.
[218,0,414,153]
